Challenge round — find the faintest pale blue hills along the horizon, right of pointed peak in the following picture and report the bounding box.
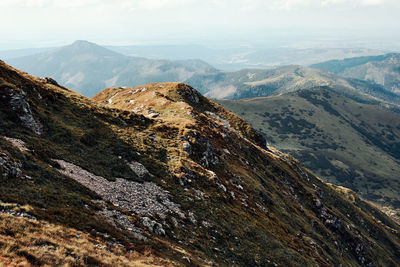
[107,44,383,71]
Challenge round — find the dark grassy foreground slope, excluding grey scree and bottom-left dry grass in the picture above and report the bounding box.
[0,63,400,266]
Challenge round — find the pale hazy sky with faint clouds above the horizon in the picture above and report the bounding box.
[0,0,400,49]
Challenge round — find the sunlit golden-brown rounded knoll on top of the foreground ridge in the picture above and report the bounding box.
[93,82,266,147]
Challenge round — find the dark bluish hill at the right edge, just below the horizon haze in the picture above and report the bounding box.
[311,54,400,95]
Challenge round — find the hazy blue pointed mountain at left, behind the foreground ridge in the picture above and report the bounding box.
[7,41,216,96]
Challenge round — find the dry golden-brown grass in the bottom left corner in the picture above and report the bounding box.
[0,214,173,266]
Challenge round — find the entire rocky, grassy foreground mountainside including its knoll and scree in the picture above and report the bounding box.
[0,59,400,266]
